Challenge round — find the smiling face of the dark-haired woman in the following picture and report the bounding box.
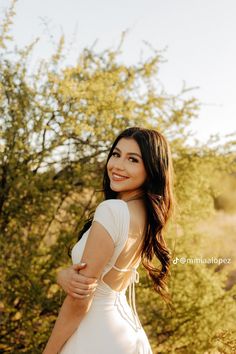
[107,138,147,200]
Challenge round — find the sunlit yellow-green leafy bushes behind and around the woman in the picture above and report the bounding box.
[0,2,235,354]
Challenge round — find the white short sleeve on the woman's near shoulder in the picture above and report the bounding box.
[93,199,129,246]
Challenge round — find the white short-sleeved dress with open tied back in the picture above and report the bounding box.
[60,199,152,354]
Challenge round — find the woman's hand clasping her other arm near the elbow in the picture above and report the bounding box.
[57,263,97,299]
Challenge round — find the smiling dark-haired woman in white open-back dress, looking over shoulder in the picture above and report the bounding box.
[43,127,173,354]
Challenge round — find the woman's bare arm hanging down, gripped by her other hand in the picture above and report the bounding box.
[43,222,114,354]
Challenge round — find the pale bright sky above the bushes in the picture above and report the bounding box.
[0,0,236,142]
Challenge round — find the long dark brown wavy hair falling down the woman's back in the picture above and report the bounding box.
[79,127,173,303]
